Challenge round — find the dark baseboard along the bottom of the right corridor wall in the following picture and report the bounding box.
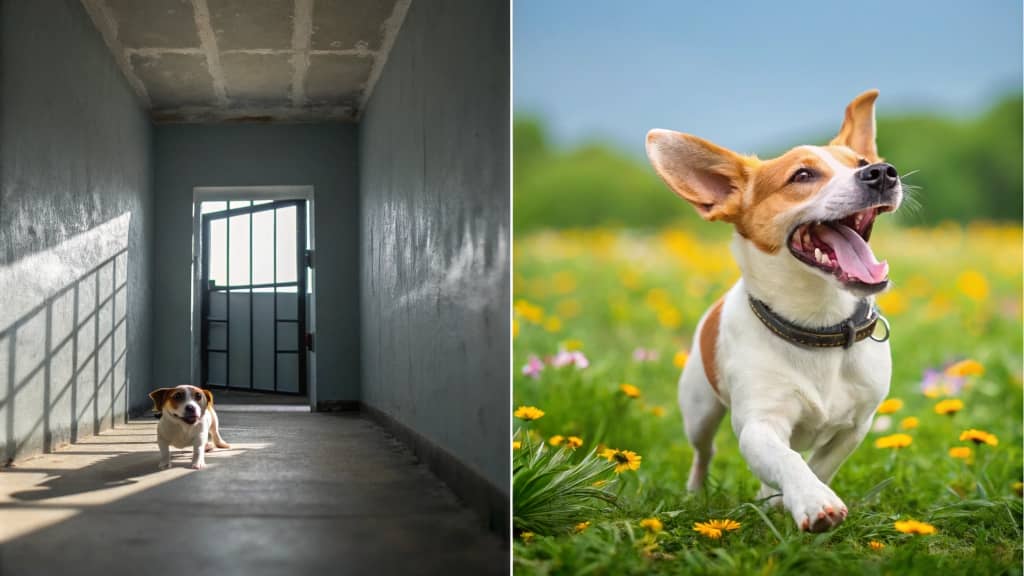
[354,402,511,541]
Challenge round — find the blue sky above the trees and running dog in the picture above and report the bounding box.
[513,0,1022,154]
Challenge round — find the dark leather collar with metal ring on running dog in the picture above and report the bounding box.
[749,296,889,348]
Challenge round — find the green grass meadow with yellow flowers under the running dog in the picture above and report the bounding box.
[513,222,1024,575]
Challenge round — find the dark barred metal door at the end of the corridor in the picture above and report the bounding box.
[200,200,312,395]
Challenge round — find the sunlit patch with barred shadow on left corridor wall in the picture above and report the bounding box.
[0,218,129,465]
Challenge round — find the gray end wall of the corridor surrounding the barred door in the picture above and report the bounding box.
[153,124,359,402]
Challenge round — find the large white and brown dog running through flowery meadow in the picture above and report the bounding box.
[647,90,903,532]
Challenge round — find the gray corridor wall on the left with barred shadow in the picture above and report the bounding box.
[0,0,153,457]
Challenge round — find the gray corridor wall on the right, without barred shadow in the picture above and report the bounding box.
[359,0,510,494]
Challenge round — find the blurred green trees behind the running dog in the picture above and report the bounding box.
[513,94,1024,233]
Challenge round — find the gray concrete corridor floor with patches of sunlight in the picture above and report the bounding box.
[0,403,509,576]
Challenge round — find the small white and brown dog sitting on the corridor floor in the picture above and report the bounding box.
[150,384,231,470]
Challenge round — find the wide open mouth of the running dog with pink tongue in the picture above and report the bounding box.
[787,206,893,288]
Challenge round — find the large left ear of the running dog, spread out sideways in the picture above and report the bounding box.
[647,130,752,221]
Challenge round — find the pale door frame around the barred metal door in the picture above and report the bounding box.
[188,186,317,410]
